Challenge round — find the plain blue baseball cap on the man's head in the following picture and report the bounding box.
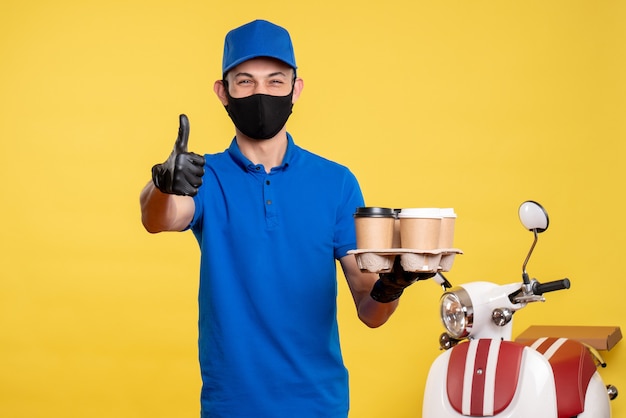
[222,20,297,74]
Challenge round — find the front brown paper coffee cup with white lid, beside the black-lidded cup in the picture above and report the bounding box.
[398,208,442,250]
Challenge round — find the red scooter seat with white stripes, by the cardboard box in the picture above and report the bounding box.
[526,337,596,418]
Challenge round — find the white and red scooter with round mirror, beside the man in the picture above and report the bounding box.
[422,201,617,418]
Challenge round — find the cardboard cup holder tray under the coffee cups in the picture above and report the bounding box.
[348,248,463,273]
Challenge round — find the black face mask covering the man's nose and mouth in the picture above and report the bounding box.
[224,85,293,139]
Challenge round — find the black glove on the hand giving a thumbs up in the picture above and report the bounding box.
[152,115,204,196]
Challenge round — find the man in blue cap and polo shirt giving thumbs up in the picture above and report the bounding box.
[140,20,424,418]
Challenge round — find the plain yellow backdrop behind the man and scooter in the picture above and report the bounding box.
[0,0,626,418]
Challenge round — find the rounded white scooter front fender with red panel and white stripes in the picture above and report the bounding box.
[422,339,557,418]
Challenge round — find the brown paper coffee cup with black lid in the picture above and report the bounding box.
[354,207,396,250]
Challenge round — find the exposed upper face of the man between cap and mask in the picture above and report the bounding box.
[226,58,294,98]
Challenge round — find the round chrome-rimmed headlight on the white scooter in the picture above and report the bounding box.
[440,287,474,339]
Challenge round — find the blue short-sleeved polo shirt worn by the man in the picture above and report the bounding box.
[191,135,363,418]
